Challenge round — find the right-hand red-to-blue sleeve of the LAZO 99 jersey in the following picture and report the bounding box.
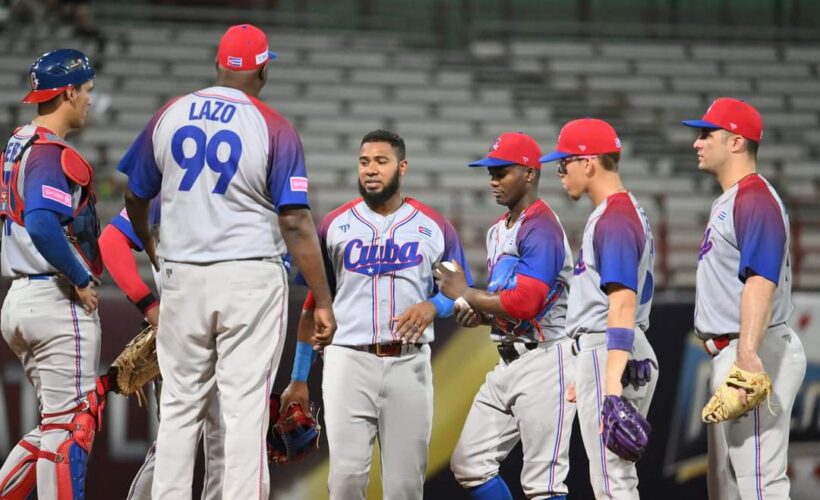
[268,120,309,212]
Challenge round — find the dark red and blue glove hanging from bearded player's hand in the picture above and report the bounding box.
[268,394,322,465]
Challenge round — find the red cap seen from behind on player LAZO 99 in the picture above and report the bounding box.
[216,24,276,71]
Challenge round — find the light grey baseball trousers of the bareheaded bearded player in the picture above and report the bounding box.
[322,345,433,500]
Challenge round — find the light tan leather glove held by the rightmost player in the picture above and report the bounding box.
[701,364,772,424]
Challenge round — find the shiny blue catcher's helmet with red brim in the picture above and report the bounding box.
[23,49,94,103]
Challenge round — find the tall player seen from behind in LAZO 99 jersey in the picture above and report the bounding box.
[117,24,335,500]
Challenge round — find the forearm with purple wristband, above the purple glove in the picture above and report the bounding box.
[605,285,637,396]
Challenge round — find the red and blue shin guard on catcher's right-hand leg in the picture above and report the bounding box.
[39,381,105,500]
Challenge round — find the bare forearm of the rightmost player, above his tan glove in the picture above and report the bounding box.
[737,276,775,357]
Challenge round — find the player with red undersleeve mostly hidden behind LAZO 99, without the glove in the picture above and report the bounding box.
[100,198,224,500]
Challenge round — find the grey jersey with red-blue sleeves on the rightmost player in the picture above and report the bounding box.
[695,174,792,339]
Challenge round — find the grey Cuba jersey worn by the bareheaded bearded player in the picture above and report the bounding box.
[319,198,472,345]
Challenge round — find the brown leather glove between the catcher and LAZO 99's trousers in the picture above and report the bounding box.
[109,326,160,406]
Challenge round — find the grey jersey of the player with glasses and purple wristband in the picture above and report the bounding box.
[567,193,655,338]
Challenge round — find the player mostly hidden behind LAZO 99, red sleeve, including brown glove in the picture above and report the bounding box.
[100,202,223,500]
